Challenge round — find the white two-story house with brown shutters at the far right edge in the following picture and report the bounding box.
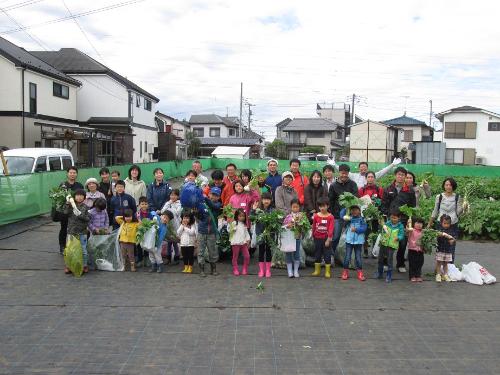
[436,106,500,166]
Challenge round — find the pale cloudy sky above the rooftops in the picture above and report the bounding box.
[0,0,500,140]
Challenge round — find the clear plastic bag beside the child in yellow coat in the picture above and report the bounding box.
[87,229,125,271]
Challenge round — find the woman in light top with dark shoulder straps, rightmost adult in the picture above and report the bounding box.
[427,177,464,263]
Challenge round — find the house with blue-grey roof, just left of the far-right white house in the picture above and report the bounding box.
[382,113,434,162]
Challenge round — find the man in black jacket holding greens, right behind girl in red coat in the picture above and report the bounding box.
[328,164,358,262]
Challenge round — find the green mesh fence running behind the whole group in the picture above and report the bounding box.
[0,159,500,225]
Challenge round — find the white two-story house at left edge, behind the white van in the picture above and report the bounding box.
[0,37,82,151]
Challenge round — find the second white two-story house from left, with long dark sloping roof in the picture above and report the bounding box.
[30,48,159,162]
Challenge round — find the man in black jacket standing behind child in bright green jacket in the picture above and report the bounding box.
[381,167,417,272]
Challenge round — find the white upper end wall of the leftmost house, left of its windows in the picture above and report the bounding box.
[0,56,22,111]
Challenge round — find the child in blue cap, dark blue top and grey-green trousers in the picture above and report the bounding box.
[198,187,222,277]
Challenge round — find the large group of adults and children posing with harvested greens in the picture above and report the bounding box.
[55,159,463,282]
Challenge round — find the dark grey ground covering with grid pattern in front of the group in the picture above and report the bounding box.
[0,218,500,375]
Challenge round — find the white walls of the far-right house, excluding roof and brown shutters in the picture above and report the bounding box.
[439,112,500,166]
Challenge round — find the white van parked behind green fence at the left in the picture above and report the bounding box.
[0,148,75,175]
